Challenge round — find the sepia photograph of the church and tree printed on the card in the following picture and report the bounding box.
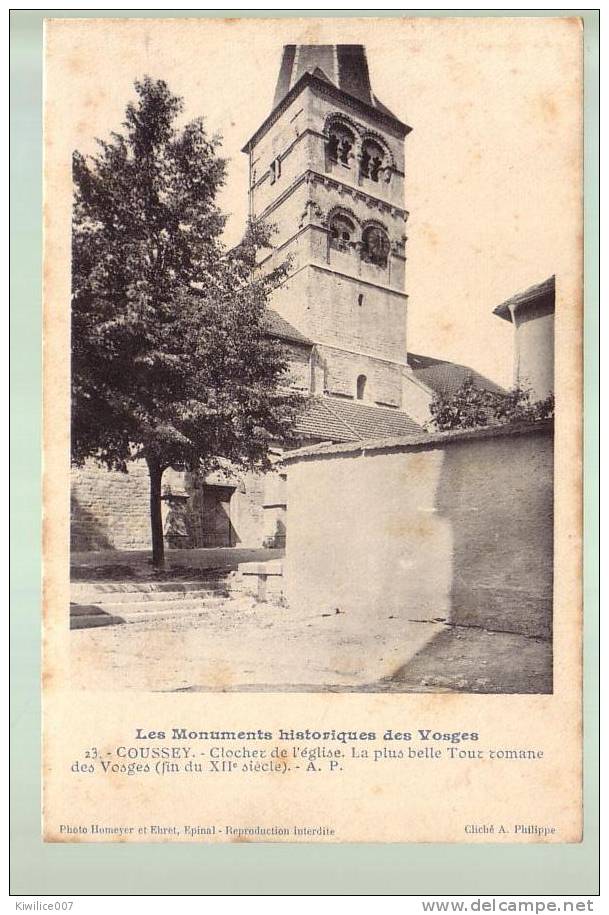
[67,23,577,694]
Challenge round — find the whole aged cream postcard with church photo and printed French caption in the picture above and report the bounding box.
[43,16,583,844]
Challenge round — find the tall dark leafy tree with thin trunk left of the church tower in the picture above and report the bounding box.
[72,77,298,567]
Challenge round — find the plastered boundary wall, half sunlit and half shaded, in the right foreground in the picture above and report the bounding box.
[285,425,553,638]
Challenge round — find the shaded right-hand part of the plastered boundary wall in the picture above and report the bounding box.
[436,432,554,640]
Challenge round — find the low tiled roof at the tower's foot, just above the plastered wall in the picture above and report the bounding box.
[296,397,422,442]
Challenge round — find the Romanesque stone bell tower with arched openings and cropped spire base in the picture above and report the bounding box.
[243,45,412,410]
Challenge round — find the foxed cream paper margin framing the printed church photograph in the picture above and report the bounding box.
[38,1,581,860]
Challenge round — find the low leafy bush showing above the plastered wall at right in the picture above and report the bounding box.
[429,377,554,432]
